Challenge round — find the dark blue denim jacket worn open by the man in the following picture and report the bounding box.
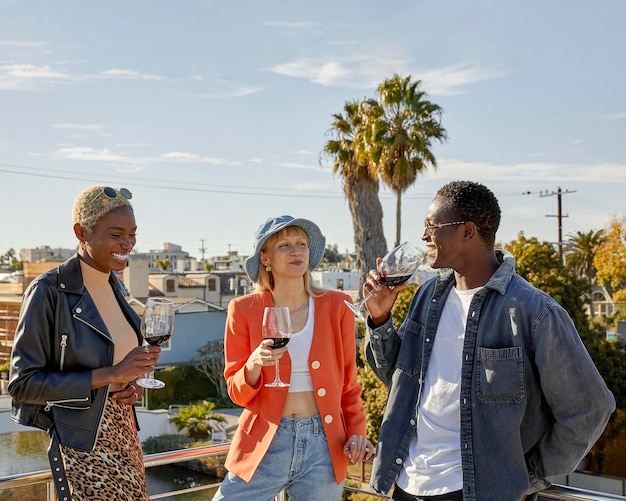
[365,252,615,501]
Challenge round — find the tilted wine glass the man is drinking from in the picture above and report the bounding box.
[344,242,427,320]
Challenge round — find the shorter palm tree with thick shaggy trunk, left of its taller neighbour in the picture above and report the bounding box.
[323,100,387,288]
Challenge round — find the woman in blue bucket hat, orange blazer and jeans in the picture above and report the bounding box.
[213,216,374,501]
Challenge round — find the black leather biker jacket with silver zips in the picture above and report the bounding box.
[8,255,141,451]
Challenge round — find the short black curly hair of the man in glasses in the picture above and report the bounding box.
[436,181,502,245]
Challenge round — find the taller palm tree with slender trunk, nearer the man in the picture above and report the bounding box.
[370,74,448,245]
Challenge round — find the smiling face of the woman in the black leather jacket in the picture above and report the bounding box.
[74,206,137,273]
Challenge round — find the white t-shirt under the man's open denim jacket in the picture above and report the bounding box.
[397,288,480,496]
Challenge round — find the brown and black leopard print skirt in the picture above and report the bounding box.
[61,398,150,501]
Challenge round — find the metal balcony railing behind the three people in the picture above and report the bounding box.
[0,443,626,501]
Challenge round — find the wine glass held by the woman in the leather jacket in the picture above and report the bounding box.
[137,297,174,389]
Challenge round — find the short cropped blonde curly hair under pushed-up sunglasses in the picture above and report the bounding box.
[72,185,133,233]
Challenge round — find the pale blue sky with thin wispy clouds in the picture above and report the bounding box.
[0,0,626,258]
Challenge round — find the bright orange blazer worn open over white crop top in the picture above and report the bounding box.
[224,290,365,483]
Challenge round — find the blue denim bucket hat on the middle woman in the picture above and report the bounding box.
[245,216,326,282]
